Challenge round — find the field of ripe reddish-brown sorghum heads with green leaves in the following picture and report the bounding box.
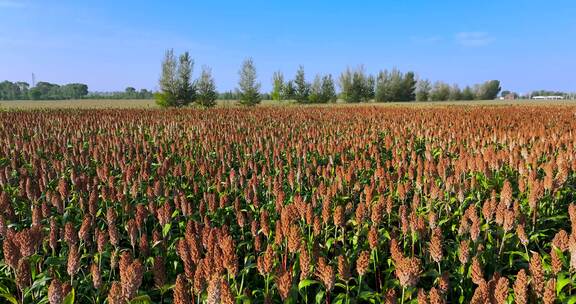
[0,106,576,304]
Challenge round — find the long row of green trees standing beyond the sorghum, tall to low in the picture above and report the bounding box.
[155,50,501,107]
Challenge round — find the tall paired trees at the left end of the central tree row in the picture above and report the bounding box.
[155,49,196,107]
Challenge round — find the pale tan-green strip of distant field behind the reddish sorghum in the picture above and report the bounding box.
[0,99,576,110]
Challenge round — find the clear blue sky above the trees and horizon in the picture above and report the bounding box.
[0,0,576,93]
